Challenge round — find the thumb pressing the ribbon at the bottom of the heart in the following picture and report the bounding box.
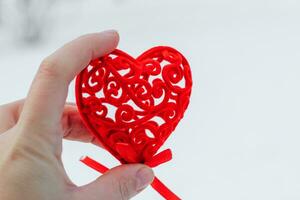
[76,164,154,200]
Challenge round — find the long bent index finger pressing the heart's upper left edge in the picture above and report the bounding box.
[21,31,118,132]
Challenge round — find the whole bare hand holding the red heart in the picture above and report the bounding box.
[0,31,154,200]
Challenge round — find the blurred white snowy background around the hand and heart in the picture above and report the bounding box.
[0,0,300,200]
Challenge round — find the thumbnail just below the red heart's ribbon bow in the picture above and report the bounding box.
[136,167,154,191]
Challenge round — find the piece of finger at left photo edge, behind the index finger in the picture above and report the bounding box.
[0,100,24,134]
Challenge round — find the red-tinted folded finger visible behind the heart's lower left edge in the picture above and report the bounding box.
[62,103,103,147]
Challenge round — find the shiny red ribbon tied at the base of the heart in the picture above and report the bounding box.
[80,149,181,200]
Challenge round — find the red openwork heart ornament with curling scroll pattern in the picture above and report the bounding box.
[76,46,192,199]
